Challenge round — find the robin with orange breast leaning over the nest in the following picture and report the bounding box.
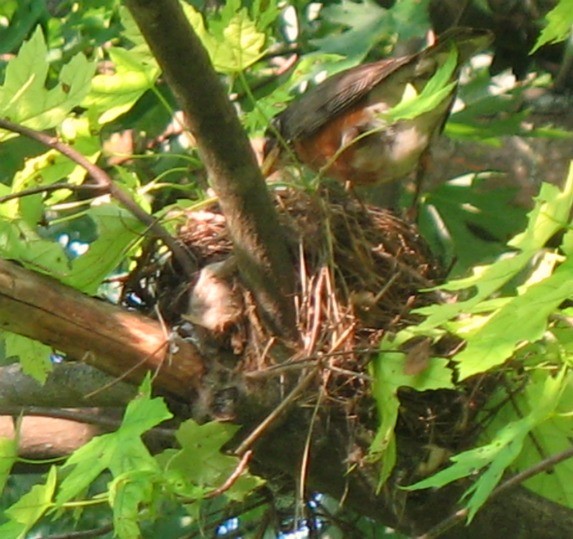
[263,28,491,191]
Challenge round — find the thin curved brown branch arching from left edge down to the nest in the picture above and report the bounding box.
[0,118,195,276]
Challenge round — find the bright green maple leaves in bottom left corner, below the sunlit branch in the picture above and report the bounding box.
[0,377,262,539]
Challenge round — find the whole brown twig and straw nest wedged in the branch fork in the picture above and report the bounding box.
[120,189,496,480]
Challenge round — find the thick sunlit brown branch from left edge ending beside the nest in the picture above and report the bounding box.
[0,260,204,398]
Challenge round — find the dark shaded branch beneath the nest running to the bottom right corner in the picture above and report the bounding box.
[253,411,573,539]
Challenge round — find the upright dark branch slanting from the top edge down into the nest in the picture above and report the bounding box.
[126,0,295,338]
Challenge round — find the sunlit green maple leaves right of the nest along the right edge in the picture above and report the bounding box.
[372,157,573,520]
